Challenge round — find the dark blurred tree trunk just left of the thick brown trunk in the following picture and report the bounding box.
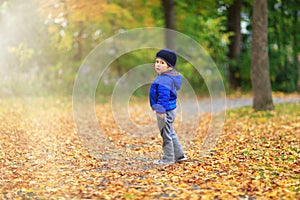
[227,0,242,89]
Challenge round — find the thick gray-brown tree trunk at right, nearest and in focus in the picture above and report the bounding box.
[251,0,274,110]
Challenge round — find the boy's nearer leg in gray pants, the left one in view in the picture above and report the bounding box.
[157,112,175,163]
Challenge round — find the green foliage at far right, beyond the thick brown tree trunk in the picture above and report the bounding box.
[268,0,300,92]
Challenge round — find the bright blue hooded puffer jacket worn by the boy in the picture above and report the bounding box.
[149,70,182,113]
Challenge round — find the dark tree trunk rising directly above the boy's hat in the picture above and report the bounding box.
[162,0,175,49]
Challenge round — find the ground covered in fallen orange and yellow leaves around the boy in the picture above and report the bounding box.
[0,98,300,199]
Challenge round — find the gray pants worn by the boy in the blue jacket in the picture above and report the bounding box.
[157,109,184,162]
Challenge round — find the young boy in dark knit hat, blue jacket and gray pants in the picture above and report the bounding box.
[149,49,187,165]
